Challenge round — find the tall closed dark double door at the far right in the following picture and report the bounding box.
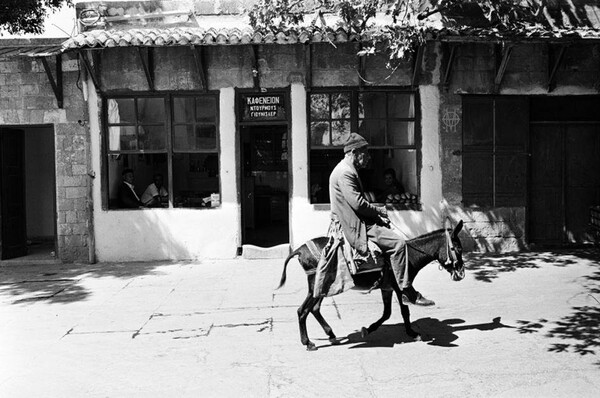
[529,97,600,246]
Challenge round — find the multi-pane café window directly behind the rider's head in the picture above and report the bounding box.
[309,89,420,209]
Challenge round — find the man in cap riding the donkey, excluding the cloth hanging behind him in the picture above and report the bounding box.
[329,133,435,306]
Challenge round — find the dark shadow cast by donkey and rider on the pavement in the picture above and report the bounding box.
[319,317,513,349]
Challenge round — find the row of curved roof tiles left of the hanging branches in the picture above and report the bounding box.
[63,27,357,50]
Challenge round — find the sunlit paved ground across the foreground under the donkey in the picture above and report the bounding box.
[0,249,600,397]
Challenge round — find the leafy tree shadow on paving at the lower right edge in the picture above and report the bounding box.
[517,271,600,366]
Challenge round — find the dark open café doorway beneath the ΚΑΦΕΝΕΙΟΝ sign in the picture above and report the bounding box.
[240,125,289,247]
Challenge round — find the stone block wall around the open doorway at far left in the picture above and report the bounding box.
[0,56,92,262]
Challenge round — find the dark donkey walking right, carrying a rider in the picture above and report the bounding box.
[277,221,465,351]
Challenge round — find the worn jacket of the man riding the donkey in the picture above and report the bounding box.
[329,158,383,255]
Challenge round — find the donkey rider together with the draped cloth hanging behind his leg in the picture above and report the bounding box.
[314,133,435,306]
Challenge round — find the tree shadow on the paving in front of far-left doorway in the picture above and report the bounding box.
[0,262,177,304]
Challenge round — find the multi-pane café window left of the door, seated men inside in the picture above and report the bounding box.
[104,94,220,209]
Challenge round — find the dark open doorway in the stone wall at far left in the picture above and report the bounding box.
[0,126,56,261]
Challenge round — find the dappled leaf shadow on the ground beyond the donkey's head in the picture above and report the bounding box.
[464,247,600,282]
